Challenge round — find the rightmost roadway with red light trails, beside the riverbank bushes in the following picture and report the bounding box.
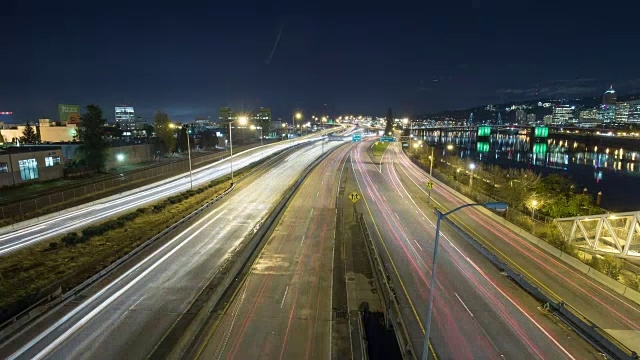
[388,145,640,353]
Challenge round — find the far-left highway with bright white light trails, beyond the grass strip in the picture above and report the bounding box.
[0,129,336,256]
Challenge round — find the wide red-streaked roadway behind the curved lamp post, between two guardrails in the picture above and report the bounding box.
[351,142,601,359]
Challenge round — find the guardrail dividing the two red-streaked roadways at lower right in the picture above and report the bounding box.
[442,214,638,359]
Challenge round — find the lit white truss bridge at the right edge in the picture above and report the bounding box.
[556,211,640,258]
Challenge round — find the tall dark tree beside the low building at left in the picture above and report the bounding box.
[78,105,109,171]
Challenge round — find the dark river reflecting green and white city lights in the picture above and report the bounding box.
[414,130,640,212]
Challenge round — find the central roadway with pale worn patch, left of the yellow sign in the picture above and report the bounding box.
[190,145,350,359]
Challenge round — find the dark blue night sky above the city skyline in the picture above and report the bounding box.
[0,0,640,121]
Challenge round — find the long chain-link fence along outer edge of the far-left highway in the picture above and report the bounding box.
[0,144,257,225]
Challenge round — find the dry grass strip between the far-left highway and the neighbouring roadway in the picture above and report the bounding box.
[0,165,255,322]
